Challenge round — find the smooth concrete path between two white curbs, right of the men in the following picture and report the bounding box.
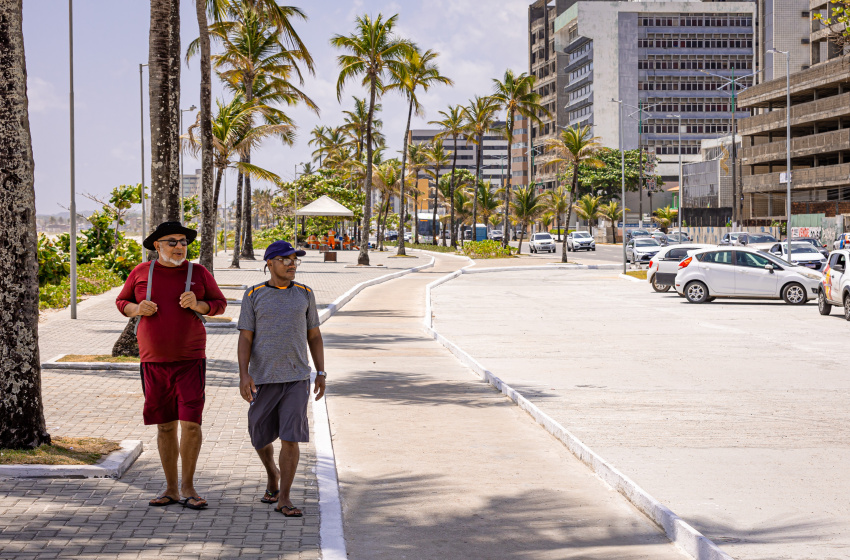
[323,257,684,560]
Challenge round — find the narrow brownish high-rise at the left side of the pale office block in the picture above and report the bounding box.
[527,0,572,189]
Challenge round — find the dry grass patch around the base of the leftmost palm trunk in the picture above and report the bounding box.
[0,437,121,465]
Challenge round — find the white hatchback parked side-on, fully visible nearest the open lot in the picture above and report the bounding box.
[675,247,823,305]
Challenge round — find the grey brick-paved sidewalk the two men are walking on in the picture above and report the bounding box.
[0,247,426,560]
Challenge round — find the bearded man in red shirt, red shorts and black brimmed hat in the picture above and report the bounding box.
[115,222,227,509]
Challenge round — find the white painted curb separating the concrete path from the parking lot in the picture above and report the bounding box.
[425,265,733,560]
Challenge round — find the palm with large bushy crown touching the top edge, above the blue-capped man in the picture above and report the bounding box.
[207,0,318,259]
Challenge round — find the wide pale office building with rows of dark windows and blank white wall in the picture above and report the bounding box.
[554,1,756,188]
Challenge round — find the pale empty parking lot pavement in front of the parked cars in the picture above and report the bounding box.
[433,270,850,559]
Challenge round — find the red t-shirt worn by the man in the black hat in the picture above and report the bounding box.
[115,261,227,362]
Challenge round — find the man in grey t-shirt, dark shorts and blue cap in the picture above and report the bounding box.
[237,241,326,517]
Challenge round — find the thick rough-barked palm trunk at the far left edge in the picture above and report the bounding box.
[0,0,50,449]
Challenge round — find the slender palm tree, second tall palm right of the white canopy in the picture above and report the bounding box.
[386,49,453,255]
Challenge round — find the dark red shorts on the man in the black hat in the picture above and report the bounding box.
[141,358,207,426]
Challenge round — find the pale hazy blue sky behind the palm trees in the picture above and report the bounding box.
[24,0,529,214]
